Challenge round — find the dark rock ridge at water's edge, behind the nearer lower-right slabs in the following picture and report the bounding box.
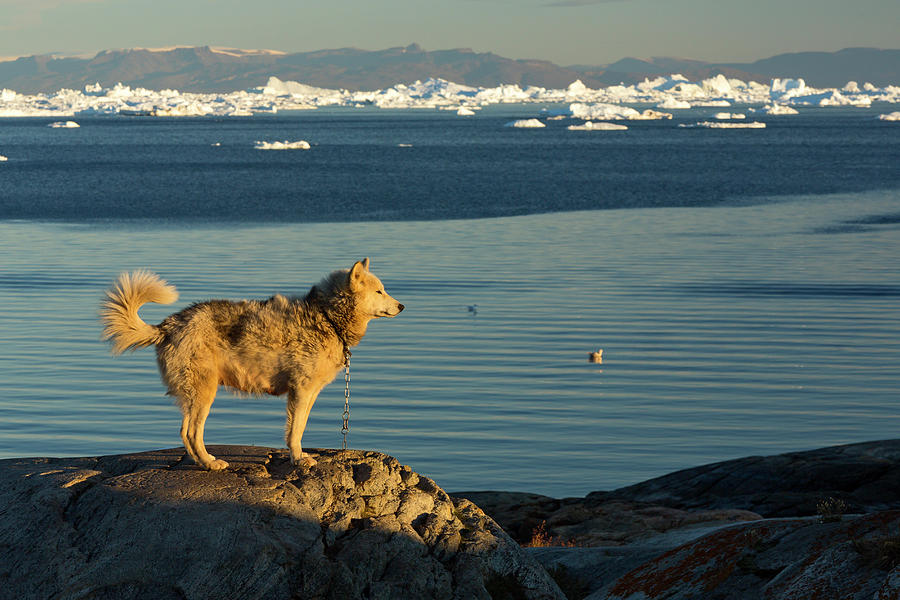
[453,440,900,546]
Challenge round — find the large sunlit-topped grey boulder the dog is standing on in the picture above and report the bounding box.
[0,446,563,600]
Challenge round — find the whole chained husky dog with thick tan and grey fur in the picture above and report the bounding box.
[100,258,403,471]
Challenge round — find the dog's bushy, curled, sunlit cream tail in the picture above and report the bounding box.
[100,271,178,354]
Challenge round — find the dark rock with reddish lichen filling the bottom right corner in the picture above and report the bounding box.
[600,511,900,600]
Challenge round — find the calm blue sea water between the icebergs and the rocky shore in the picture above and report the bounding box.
[0,107,900,496]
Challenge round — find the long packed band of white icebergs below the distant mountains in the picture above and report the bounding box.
[0,74,900,120]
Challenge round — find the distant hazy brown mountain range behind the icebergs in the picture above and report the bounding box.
[0,44,900,94]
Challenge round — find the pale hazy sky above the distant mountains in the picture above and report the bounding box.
[0,0,900,65]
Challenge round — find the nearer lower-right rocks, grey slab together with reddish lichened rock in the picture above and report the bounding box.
[529,511,900,600]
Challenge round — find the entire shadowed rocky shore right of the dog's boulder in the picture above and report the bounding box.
[461,440,900,600]
